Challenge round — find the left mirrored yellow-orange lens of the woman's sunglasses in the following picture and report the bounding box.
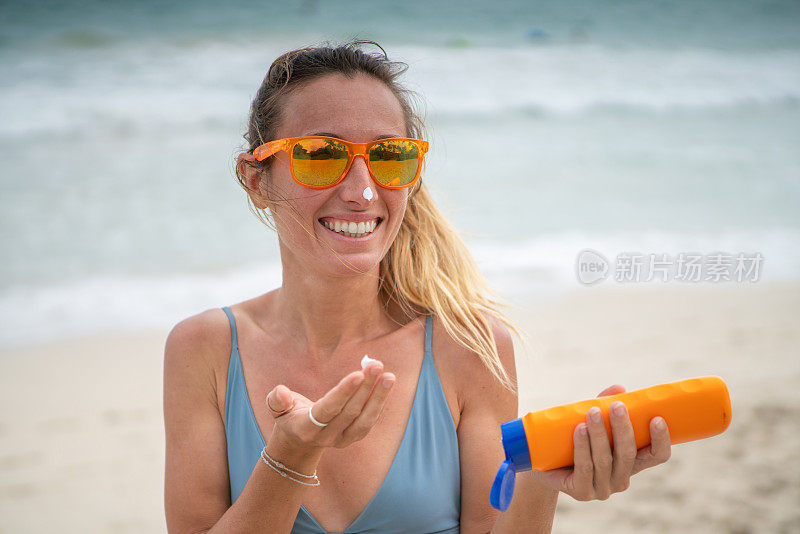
[292,139,347,186]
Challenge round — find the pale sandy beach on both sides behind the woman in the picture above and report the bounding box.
[0,284,800,533]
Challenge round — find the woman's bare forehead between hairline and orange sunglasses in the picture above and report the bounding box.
[278,74,406,142]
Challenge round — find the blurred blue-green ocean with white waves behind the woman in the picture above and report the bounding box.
[0,0,800,347]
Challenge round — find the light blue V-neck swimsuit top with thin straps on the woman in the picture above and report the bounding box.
[222,306,461,534]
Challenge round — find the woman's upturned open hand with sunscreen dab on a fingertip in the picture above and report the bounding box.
[267,360,395,449]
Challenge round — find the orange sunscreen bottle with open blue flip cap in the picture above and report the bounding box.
[489,376,731,511]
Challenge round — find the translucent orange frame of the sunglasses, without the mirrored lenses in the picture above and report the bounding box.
[253,135,428,189]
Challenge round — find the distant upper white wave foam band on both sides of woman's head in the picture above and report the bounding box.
[0,41,800,137]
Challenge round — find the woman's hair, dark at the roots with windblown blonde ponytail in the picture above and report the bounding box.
[231,40,518,391]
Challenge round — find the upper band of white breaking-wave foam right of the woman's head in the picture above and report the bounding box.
[406,45,800,115]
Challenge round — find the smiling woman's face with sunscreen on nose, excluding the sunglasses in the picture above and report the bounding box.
[268,74,408,275]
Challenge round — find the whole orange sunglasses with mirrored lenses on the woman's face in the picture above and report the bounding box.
[253,135,428,189]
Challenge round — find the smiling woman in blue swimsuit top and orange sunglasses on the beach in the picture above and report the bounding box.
[164,42,670,533]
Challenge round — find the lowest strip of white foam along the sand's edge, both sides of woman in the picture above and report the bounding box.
[0,229,800,348]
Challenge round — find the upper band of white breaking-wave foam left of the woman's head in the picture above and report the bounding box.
[0,41,279,137]
